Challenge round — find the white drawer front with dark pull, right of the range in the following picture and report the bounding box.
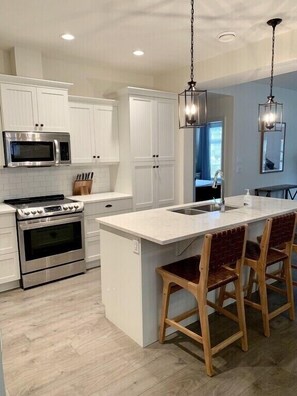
[84,198,132,217]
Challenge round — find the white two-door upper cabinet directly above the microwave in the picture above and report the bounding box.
[0,76,71,132]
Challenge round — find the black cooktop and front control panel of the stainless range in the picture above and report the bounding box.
[4,194,84,220]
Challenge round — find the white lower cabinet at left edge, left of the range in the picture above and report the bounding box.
[0,213,20,285]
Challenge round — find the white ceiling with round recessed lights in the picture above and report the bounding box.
[0,0,297,81]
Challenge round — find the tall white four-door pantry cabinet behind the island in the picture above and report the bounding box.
[115,87,177,210]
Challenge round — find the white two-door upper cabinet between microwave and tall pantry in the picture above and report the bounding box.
[69,96,119,163]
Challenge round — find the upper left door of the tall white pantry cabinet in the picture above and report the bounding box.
[130,97,157,161]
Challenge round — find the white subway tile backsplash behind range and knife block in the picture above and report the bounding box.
[0,165,110,202]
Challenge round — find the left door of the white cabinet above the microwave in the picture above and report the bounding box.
[1,84,39,131]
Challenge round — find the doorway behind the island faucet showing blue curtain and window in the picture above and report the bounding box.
[194,121,223,202]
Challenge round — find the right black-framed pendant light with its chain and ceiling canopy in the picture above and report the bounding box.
[258,18,283,132]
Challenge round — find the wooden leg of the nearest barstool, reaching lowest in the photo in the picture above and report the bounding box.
[197,296,214,377]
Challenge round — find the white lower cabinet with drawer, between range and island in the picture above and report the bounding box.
[84,198,132,269]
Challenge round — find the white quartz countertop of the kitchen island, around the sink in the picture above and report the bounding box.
[97,195,297,245]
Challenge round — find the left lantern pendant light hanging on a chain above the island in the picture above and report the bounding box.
[178,0,207,129]
